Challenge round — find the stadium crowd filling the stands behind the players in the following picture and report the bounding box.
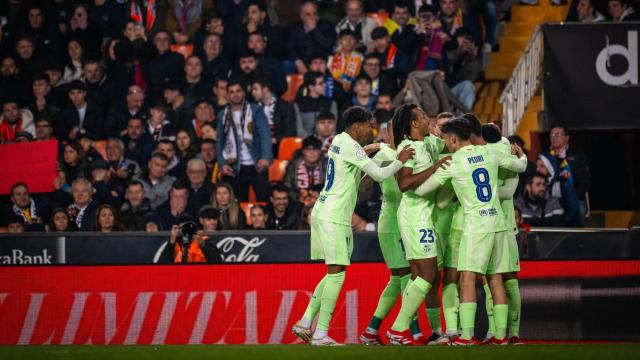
[0,0,592,232]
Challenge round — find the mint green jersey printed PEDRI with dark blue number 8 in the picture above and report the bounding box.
[433,145,526,234]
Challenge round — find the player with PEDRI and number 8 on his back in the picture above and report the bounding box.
[415,119,527,345]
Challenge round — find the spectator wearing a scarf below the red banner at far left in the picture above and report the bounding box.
[0,182,53,231]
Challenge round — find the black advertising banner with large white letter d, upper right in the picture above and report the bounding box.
[543,22,640,129]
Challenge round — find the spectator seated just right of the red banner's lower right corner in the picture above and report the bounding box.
[67,179,99,231]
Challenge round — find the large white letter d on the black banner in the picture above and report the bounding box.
[596,31,639,86]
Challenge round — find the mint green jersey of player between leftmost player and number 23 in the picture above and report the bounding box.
[373,144,402,234]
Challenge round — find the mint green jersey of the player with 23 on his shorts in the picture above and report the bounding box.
[398,136,444,227]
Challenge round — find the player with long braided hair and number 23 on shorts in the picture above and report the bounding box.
[387,104,448,345]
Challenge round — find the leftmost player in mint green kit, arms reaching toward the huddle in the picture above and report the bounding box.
[292,106,414,346]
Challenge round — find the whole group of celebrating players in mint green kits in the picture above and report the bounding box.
[292,104,527,346]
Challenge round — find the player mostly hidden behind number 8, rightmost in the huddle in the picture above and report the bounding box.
[482,124,522,345]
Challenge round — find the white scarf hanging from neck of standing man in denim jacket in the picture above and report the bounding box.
[222,102,253,163]
